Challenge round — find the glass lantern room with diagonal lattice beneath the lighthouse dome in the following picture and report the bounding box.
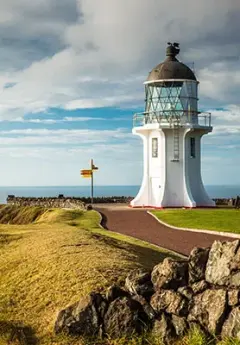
[145,80,198,116]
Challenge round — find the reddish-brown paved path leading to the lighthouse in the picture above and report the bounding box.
[94,204,234,255]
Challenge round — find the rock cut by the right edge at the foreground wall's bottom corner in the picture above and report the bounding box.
[221,307,240,339]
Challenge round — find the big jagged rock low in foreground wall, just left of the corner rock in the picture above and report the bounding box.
[188,289,227,334]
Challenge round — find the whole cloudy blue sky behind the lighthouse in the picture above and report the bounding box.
[0,0,240,186]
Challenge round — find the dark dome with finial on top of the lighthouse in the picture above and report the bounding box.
[147,43,196,82]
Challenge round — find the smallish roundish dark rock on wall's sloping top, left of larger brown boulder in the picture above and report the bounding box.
[125,269,154,297]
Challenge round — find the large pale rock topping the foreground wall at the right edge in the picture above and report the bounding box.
[206,240,240,287]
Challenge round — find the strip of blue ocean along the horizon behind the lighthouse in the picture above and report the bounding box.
[0,185,240,204]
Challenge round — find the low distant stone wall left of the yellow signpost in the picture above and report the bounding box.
[7,195,85,209]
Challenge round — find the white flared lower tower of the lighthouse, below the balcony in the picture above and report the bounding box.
[131,124,215,207]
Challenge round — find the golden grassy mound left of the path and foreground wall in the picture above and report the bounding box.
[0,206,180,345]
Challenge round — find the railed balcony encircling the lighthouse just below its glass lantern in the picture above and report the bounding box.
[133,110,212,129]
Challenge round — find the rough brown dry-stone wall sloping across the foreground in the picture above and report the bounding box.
[55,240,240,344]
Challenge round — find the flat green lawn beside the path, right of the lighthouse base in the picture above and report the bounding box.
[152,208,240,234]
